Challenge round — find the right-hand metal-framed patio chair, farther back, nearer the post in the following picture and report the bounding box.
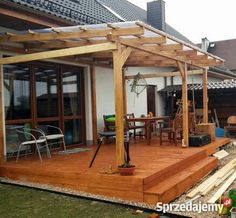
[37,125,66,151]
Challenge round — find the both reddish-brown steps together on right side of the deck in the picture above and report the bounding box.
[144,153,217,204]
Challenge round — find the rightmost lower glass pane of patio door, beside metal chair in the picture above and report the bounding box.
[65,120,82,145]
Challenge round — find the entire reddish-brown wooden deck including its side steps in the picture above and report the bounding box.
[0,138,230,204]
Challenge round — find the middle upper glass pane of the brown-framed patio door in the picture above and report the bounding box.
[35,68,58,117]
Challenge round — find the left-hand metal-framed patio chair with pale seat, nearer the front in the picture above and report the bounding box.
[16,128,51,162]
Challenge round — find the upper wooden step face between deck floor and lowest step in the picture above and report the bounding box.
[144,150,207,190]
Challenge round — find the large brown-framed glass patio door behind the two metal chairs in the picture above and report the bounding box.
[3,63,85,155]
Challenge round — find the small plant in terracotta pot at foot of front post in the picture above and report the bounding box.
[118,142,135,176]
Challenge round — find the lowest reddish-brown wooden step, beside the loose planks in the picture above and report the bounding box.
[144,157,218,204]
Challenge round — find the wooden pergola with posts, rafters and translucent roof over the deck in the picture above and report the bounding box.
[0,22,224,164]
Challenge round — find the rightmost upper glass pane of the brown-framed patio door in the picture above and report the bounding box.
[63,71,81,116]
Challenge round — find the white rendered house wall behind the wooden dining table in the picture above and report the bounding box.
[96,67,222,129]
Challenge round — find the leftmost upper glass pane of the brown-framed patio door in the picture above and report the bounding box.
[3,65,31,120]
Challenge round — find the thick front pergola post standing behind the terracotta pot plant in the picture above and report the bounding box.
[113,45,125,165]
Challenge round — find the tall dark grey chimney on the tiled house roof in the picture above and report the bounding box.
[147,0,166,32]
